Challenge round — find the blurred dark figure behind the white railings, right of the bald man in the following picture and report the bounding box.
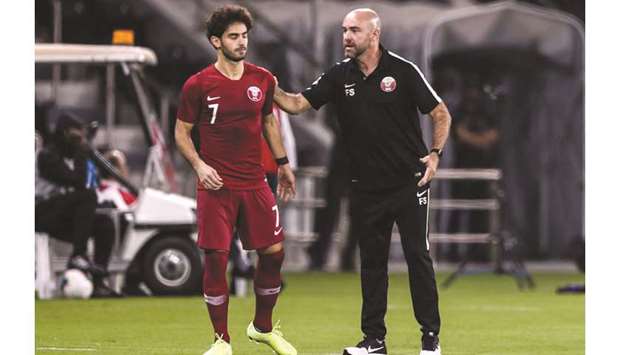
[449,82,499,261]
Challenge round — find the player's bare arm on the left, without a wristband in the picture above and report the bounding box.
[174,119,224,190]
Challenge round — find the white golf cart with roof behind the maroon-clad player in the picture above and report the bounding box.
[35,44,202,299]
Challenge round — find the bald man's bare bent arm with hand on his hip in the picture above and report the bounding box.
[418,102,452,186]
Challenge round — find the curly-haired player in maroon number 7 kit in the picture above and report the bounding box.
[175,6,297,355]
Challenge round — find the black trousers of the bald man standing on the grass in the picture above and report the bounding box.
[351,184,440,339]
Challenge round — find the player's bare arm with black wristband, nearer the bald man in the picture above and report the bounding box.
[263,113,295,202]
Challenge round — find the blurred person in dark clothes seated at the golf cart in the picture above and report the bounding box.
[35,114,119,297]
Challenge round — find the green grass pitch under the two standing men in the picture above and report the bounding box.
[35,273,585,355]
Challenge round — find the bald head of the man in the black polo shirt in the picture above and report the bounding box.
[342,8,381,58]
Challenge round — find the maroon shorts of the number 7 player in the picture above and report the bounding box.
[196,183,284,251]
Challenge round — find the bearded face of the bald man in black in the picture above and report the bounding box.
[342,12,377,58]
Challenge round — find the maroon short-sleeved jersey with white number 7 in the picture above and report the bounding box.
[177,62,275,190]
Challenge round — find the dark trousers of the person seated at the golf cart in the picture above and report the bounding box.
[35,190,115,268]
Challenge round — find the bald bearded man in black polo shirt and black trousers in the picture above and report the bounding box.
[274,9,451,355]
